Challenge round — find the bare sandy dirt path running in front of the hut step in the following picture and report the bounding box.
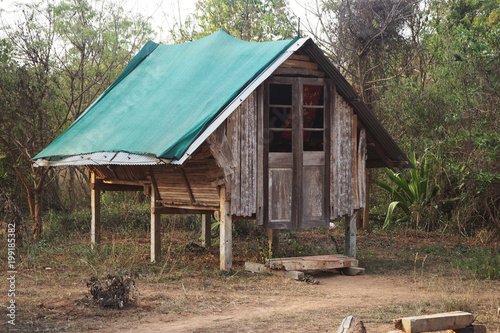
[94,275,446,333]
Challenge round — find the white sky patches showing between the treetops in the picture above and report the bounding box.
[0,0,315,43]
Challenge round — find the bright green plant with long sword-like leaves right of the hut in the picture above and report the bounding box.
[378,153,441,229]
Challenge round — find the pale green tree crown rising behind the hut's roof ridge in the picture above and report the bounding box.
[170,0,296,42]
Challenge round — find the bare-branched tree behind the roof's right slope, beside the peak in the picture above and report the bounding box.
[305,0,421,103]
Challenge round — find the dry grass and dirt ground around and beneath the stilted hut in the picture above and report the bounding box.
[0,222,500,332]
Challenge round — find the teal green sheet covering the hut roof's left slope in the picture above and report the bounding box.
[34,30,297,161]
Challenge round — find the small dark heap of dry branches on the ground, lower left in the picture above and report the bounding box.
[87,274,137,309]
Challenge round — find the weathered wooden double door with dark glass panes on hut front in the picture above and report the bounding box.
[264,78,330,229]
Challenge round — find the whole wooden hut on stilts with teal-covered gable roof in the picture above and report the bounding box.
[35,31,410,269]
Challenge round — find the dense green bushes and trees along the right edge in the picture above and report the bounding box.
[374,0,500,235]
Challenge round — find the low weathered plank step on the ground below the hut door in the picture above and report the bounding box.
[265,255,358,271]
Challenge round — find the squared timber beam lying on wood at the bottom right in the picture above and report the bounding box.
[394,311,474,333]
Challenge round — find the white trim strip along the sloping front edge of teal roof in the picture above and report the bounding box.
[171,37,309,165]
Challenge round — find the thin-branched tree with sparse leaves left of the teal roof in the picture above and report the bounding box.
[0,0,151,239]
